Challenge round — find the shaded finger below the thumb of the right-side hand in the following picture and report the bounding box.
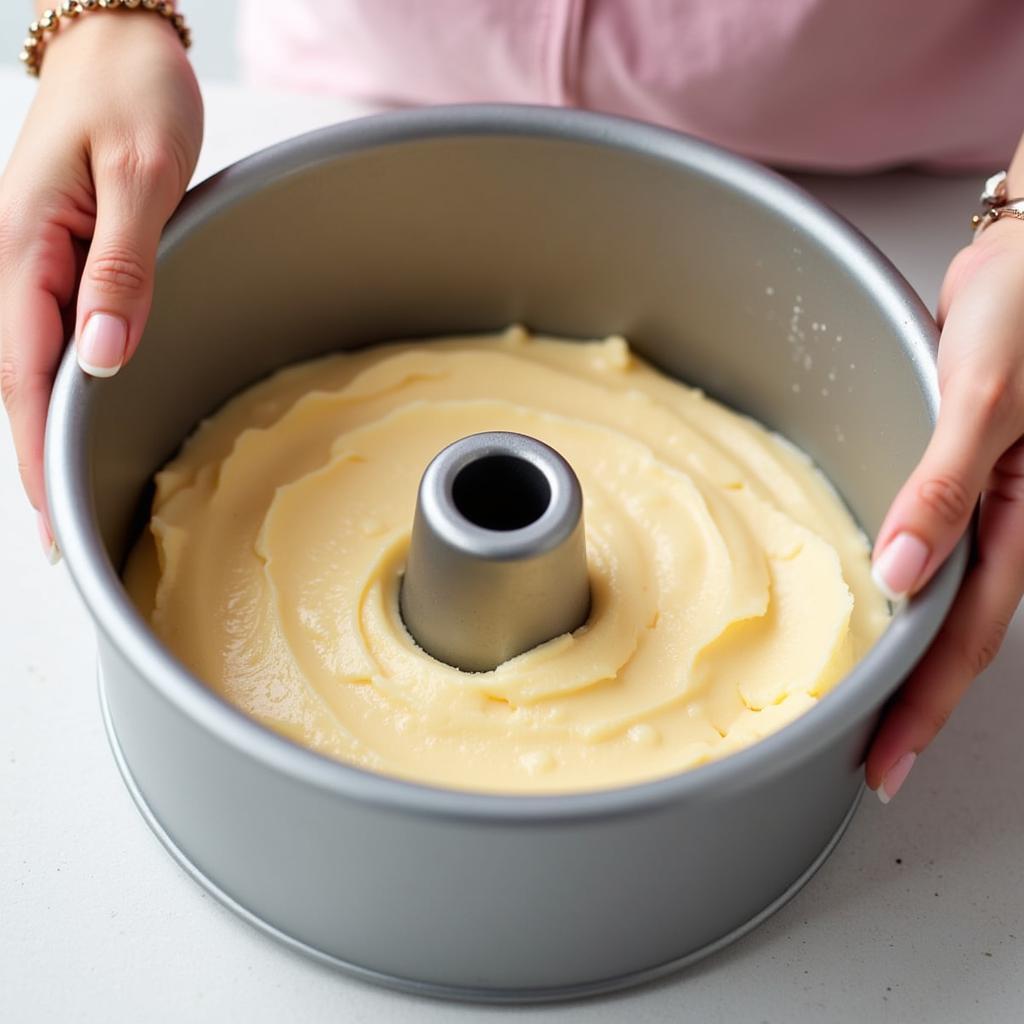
[867,445,1024,801]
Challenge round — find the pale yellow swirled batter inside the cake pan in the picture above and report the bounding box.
[127,328,889,793]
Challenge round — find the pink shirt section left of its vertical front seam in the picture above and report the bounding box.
[241,0,585,105]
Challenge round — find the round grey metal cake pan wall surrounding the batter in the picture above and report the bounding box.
[46,106,967,1000]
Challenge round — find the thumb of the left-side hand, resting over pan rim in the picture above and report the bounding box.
[75,152,178,377]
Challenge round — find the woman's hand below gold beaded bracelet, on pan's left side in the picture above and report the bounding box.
[0,9,203,558]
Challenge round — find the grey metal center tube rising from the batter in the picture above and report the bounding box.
[400,432,590,672]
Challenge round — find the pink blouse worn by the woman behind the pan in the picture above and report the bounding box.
[241,0,1024,171]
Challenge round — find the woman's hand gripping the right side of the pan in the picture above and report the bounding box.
[867,216,1024,803]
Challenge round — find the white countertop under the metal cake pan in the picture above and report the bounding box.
[0,71,1024,1024]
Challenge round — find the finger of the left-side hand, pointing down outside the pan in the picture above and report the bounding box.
[0,223,75,532]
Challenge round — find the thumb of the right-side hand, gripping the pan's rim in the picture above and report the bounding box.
[873,375,1011,601]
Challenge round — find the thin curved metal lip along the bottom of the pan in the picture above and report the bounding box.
[97,671,864,1004]
